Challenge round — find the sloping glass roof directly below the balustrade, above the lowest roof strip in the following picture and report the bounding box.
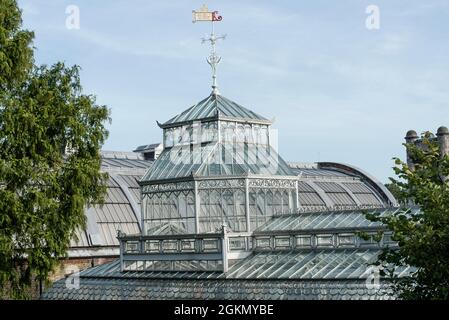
[51,249,414,280]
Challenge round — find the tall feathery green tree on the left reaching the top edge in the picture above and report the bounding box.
[0,0,109,298]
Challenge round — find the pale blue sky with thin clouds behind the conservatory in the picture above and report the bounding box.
[18,0,449,182]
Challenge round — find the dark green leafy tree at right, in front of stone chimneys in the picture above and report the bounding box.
[368,132,449,299]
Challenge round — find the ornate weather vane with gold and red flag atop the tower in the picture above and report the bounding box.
[192,5,226,94]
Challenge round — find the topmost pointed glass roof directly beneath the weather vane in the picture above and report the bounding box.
[161,94,271,127]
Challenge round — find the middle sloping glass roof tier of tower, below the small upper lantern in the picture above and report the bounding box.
[141,142,294,182]
